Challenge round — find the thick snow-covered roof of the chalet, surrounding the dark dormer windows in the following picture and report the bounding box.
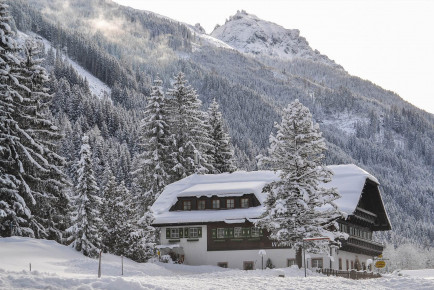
[152,164,379,224]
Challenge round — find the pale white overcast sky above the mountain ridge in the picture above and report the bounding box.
[114,0,434,113]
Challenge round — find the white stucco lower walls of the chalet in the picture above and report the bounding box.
[160,225,372,270]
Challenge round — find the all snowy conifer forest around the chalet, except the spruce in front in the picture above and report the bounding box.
[0,0,434,262]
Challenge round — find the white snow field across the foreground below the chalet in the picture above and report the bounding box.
[0,237,434,290]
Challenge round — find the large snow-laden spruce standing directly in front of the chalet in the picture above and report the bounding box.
[257,100,341,250]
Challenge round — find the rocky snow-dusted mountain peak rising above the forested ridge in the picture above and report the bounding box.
[211,10,337,67]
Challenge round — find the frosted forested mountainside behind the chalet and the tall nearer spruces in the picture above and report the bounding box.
[7,0,434,247]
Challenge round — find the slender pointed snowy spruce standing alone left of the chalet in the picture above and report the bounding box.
[67,135,102,257]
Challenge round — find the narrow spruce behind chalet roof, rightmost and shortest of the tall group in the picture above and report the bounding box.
[208,99,236,173]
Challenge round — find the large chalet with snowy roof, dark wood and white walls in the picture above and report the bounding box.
[152,164,391,270]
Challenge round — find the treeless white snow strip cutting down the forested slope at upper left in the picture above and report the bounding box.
[18,31,111,98]
